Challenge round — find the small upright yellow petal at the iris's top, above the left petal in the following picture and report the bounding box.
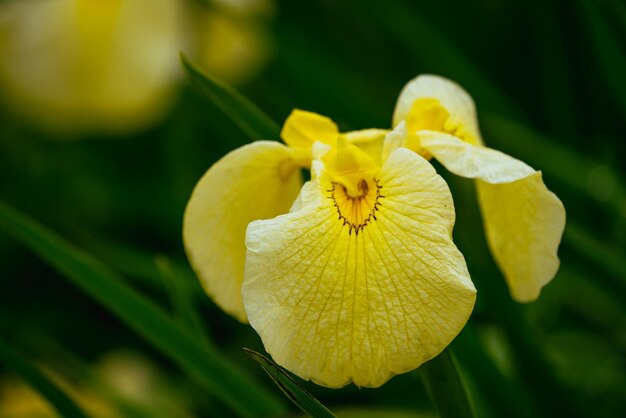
[280,109,339,148]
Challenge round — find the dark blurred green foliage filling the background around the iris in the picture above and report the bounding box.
[0,0,626,417]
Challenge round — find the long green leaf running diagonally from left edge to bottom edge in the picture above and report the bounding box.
[0,202,285,417]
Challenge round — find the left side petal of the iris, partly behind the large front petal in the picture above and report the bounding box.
[183,141,302,322]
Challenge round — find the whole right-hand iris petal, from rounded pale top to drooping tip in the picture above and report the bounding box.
[393,75,565,302]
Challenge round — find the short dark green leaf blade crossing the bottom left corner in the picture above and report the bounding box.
[0,338,87,418]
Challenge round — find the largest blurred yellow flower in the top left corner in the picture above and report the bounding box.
[0,0,180,133]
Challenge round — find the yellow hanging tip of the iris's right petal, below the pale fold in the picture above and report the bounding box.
[477,172,565,302]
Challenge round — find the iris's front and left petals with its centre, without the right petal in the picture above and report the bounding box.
[183,111,476,387]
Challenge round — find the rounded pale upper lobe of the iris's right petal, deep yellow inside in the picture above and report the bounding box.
[393,74,482,144]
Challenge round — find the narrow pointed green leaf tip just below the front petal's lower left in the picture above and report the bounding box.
[244,348,334,418]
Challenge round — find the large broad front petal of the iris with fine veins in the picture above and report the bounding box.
[243,148,475,387]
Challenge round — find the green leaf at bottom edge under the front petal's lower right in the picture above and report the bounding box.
[418,348,474,418]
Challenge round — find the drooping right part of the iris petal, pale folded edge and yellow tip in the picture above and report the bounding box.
[418,131,565,302]
